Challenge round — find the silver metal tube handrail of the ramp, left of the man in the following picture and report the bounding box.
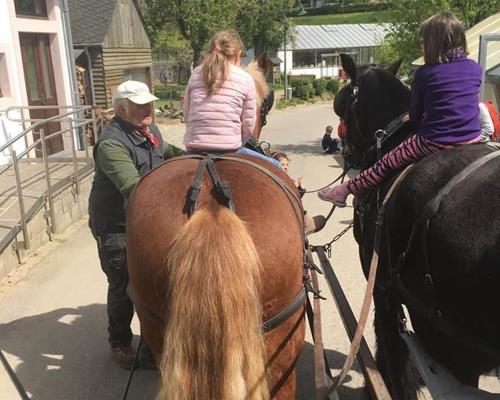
[0,105,102,253]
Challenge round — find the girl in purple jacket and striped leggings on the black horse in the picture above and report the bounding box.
[318,11,482,207]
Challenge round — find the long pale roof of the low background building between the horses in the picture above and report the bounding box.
[287,24,389,50]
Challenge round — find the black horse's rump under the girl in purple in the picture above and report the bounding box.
[385,144,500,373]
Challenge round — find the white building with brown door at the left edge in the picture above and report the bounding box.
[0,0,73,163]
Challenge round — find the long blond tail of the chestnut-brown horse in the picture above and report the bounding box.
[157,208,269,400]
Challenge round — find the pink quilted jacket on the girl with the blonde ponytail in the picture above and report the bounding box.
[184,64,257,151]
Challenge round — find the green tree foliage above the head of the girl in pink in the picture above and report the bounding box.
[141,0,297,65]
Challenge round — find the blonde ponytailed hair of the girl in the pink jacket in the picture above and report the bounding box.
[202,30,245,96]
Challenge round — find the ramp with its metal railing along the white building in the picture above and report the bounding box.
[0,105,99,259]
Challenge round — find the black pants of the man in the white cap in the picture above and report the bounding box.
[92,232,134,346]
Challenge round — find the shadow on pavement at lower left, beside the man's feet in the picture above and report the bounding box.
[0,304,157,400]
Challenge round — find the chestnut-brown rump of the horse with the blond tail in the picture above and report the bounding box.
[127,155,304,398]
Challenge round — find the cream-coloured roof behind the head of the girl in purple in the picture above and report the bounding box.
[412,12,500,71]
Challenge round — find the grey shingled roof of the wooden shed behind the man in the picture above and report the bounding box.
[68,0,117,45]
